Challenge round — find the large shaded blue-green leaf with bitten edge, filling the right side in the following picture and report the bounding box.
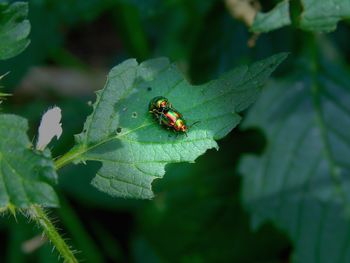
[240,55,350,263]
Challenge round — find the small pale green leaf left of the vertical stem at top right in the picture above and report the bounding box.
[251,0,291,32]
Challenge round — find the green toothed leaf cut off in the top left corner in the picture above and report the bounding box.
[0,2,30,60]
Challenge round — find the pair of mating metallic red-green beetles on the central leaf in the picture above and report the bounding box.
[149,96,197,136]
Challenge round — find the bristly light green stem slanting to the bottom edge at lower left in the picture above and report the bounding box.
[29,205,78,263]
